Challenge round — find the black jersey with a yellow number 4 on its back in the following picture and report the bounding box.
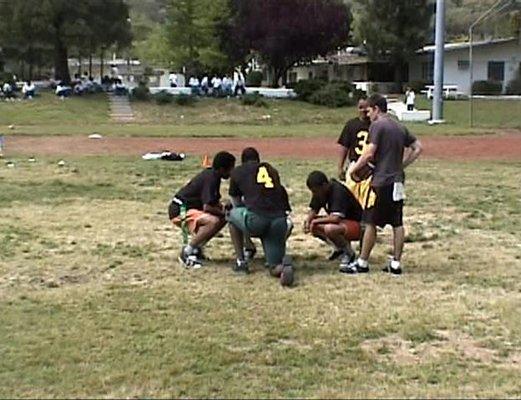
[229,162,291,217]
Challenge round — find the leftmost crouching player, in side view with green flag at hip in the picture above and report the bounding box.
[168,151,235,268]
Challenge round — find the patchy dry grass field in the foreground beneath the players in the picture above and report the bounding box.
[0,155,521,398]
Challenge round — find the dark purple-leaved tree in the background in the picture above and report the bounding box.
[223,0,351,87]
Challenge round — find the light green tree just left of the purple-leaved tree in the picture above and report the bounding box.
[165,0,227,75]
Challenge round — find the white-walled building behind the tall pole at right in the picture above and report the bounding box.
[409,38,521,95]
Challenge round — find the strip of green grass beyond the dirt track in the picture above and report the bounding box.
[0,93,521,137]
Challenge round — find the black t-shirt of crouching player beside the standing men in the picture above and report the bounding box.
[309,179,362,221]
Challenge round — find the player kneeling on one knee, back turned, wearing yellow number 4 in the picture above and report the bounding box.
[228,148,294,286]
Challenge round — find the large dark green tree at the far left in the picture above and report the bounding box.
[0,0,131,81]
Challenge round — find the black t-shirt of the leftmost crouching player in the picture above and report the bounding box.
[175,168,221,210]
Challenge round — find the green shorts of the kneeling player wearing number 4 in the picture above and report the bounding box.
[228,207,288,266]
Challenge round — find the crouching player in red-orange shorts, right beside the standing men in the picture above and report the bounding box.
[304,171,362,268]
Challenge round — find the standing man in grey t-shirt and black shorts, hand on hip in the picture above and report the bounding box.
[341,94,423,275]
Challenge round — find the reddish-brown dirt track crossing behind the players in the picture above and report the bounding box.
[5,131,521,161]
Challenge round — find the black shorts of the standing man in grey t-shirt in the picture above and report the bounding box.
[363,185,403,228]
